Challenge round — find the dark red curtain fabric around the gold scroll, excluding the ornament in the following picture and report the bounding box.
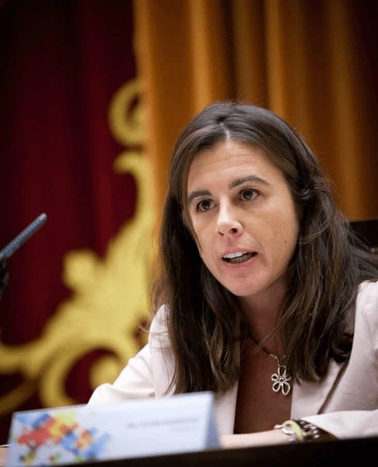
[0,0,136,443]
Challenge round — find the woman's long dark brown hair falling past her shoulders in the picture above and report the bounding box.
[153,101,378,393]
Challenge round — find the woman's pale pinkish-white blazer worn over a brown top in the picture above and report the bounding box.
[88,282,378,439]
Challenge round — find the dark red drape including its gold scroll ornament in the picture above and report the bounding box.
[0,0,148,443]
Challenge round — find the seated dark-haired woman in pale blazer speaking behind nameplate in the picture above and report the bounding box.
[89,102,378,447]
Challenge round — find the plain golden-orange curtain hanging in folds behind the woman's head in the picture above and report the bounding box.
[134,0,378,220]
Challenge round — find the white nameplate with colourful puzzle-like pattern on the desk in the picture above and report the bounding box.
[6,392,219,467]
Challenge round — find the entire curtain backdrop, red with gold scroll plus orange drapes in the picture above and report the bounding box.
[0,0,378,443]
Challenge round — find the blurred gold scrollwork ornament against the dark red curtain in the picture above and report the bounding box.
[0,80,155,415]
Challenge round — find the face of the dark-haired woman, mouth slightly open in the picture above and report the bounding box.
[187,141,299,303]
